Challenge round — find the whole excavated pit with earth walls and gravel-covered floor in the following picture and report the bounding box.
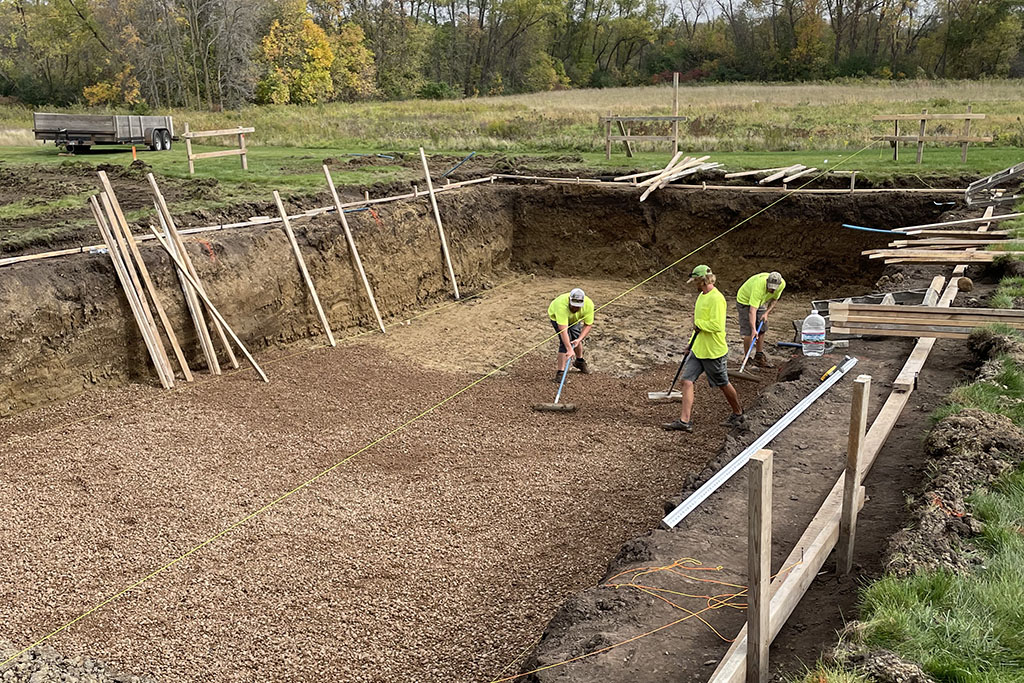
[0,184,958,681]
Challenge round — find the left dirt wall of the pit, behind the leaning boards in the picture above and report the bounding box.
[0,185,513,416]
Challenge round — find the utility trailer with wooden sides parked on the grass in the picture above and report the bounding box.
[32,112,178,153]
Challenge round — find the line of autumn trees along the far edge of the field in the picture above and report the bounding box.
[0,0,1024,111]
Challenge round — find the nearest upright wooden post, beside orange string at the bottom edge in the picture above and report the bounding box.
[746,449,772,683]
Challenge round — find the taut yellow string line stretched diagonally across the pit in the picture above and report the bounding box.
[0,144,870,667]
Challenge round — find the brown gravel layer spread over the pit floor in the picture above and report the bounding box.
[0,278,754,682]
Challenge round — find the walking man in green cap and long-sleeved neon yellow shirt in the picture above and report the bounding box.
[663,265,744,432]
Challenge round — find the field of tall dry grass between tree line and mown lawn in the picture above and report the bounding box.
[0,80,1024,153]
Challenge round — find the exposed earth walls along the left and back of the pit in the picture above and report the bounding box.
[0,184,940,416]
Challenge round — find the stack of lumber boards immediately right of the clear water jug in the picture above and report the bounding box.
[828,303,1024,339]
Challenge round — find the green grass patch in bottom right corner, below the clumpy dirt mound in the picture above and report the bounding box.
[861,464,1024,683]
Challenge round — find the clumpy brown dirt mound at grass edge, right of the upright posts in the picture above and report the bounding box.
[887,410,1024,577]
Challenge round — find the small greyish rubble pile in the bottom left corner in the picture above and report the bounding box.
[0,641,156,683]
